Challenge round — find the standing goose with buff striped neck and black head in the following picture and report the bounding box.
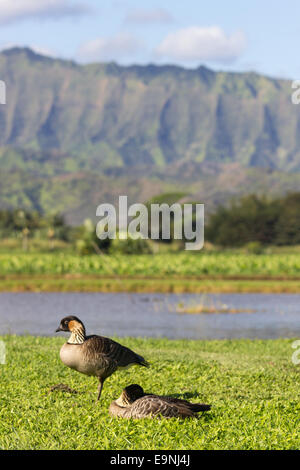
[56,316,149,400]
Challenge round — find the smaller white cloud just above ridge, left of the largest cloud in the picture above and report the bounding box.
[77,33,143,61]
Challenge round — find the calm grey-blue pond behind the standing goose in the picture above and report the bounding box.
[0,293,300,339]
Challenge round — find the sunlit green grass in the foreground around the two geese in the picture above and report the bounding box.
[0,336,300,450]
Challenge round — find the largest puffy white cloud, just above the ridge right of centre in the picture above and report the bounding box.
[154,26,246,63]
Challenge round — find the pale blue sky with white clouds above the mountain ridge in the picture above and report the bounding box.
[0,0,300,79]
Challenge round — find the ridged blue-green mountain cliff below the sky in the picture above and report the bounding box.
[0,49,300,222]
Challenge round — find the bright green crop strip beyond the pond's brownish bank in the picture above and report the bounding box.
[0,253,300,277]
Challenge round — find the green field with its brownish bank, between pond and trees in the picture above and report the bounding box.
[0,252,300,293]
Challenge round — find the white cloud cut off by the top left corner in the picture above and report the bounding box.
[0,0,89,25]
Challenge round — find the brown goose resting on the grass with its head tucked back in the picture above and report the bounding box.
[109,384,211,418]
